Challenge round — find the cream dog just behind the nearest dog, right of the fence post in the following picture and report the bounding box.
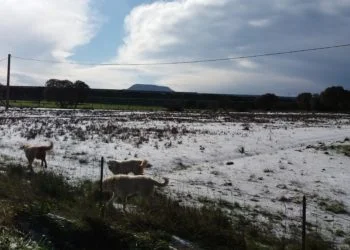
[107,160,151,175]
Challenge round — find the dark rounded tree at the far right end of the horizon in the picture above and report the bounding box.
[320,86,349,111]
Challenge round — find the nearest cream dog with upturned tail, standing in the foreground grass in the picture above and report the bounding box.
[102,175,169,212]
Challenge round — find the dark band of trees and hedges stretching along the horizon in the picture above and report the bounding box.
[0,79,350,112]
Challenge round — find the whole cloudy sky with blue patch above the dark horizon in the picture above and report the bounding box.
[0,0,350,96]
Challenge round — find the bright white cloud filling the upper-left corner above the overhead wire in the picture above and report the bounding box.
[0,0,98,59]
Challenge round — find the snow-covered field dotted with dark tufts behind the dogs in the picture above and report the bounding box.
[0,109,350,243]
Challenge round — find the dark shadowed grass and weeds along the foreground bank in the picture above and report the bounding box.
[0,165,329,249]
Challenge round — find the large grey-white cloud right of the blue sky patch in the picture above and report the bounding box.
[117,0,350,95]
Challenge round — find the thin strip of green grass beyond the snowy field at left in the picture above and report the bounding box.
[10,100,165,111]
